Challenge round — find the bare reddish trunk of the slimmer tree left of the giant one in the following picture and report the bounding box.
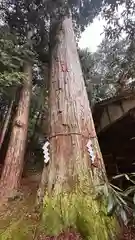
[0,63,32,197]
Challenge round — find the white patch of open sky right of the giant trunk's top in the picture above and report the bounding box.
[79,17,106,52]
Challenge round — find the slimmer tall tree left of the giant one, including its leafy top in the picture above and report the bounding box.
[0,1,44,197]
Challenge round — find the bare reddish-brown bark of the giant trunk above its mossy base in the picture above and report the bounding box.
[48,17,105,195]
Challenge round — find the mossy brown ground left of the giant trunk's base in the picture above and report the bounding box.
[0,172,44,240]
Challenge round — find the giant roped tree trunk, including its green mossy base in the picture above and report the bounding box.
[43,17,119,240]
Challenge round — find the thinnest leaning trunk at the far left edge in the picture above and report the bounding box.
[0,100,14,149]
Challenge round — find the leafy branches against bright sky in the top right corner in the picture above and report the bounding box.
[102,0,135,40]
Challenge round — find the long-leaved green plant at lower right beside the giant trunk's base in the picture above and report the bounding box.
[97,173,135,225]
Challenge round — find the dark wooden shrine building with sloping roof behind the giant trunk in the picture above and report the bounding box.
[93,90,135,187]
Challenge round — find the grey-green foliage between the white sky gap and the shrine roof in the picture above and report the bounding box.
[79,37,135,103]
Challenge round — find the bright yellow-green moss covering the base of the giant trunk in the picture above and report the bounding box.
[43,186,117,240]
